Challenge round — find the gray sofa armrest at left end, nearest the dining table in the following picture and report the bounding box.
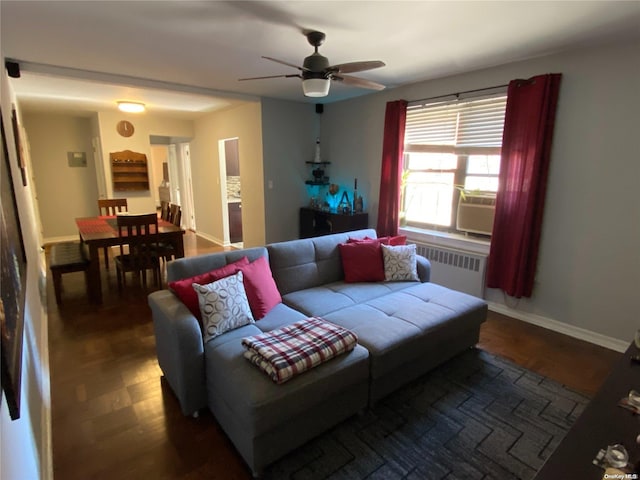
[148,290,207,415]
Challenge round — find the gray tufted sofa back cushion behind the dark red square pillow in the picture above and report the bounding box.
[267,229,376,295]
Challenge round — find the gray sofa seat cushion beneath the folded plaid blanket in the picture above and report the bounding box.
[205,324,369,437]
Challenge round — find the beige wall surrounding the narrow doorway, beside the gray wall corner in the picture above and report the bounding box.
[191,102,265,247]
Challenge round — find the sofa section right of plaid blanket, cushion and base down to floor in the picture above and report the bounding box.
[325,283,487,404]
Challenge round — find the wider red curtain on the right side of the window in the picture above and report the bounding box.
[487,74,561,298]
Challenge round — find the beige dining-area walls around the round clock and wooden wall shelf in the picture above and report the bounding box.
[24,111,194,242]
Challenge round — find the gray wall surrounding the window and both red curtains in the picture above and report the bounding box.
[322,41,640,340]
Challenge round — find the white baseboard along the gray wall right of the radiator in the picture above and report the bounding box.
[487,302,629,352]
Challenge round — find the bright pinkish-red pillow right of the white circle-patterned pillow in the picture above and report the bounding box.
[240,257,282,320]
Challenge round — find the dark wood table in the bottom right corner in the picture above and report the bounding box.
[535,342,640,480]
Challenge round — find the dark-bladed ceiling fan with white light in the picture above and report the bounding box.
[239,31,385,97]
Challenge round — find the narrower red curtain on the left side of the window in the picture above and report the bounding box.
[376,100,407,237]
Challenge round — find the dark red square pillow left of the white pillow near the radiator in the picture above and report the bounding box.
[338,241,384,283]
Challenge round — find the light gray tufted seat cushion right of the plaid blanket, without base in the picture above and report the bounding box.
[324,283,487,379]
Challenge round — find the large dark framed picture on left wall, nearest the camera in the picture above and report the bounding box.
[0,108,27,420]
